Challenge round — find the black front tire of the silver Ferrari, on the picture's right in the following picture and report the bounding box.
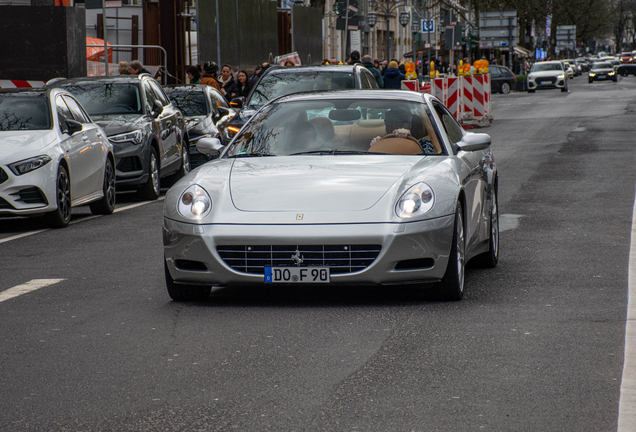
[438,201,466,301]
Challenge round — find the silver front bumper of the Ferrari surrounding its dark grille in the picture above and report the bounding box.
[163,215,454,286]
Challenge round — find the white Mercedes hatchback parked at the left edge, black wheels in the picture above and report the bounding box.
[0,89,115,228]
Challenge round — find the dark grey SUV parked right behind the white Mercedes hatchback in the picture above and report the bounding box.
[48,74,190,200]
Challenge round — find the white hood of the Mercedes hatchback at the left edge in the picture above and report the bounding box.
[0,130,57,164]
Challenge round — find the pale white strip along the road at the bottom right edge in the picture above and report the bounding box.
[618,194,636,432]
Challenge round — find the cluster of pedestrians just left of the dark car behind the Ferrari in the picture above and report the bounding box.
[186,62,253,102]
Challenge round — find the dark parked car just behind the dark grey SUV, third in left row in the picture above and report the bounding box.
[163,84,235,169]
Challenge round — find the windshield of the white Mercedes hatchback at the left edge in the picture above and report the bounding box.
[0,94,51,131]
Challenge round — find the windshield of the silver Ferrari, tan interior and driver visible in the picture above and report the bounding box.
[224,99,445,157]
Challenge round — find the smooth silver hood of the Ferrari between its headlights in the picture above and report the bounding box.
[230,155,421,212]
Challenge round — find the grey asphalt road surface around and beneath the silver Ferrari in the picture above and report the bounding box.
[0,77,636,432]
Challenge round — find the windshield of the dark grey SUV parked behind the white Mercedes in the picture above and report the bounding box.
[59,82,141,115]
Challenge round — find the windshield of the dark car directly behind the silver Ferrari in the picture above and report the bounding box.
[247,70,356,109]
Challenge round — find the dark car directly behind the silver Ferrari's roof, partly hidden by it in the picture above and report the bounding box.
[222,64,379,144]
